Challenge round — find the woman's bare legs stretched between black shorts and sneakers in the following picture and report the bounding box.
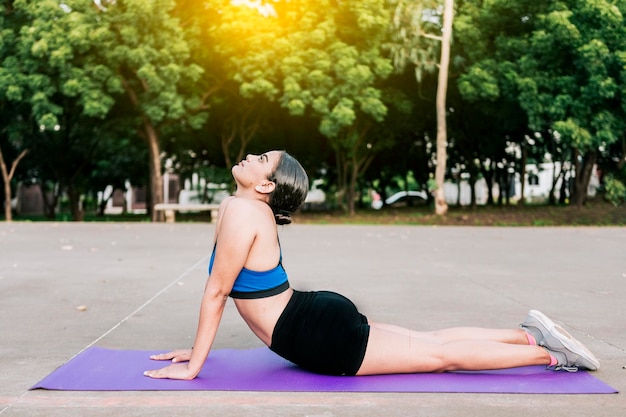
[357,323,551,375]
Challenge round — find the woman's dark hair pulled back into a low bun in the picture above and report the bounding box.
[268,151,309,224]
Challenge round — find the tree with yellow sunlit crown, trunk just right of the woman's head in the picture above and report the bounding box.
[212,0,393,213]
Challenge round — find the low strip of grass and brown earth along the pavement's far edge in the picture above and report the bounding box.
[6,200,626,227]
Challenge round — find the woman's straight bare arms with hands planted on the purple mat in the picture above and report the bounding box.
[144,200,258,379]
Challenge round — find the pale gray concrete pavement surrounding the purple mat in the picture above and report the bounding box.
[0,223,626,417]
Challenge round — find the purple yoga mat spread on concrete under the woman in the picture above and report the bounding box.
[31,347,617,394]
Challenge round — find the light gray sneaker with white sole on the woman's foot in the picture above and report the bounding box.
[520,310,600,372]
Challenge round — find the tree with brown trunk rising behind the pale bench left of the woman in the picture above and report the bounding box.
[94,0,207,221]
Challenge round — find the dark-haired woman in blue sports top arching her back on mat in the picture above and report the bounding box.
[145,151,599,379]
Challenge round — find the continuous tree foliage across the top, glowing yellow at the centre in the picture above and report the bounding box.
[0,0,626,220]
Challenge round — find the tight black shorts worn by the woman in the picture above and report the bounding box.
[270,291,370,375]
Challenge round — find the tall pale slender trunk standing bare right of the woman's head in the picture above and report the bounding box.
[435,0,454,216]
